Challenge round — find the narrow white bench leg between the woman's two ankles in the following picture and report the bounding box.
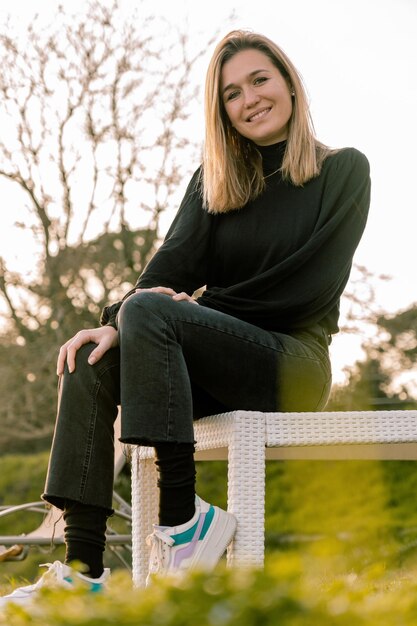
[132,446,158,587]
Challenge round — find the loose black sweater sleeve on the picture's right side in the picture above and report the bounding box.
[199,148,370,329]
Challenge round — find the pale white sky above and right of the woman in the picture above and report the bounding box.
[0,0,417,379]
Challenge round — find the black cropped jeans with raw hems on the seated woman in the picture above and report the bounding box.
[43,292,331,510]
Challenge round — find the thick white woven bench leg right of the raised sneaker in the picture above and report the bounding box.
[227,414,265,567]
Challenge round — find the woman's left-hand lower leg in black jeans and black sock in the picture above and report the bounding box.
[42,344,120,578]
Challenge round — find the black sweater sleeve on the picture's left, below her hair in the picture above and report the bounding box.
[100,169,212,328]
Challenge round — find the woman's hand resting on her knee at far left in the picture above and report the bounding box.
[56,326,119,376]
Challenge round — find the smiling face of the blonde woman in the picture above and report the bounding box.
[221,48,292,146]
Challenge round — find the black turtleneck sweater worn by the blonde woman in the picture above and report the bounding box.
[101,142,370,334]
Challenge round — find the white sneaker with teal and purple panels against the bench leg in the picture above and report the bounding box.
[146,496,237,584]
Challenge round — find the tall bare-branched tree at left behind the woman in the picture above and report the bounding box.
[0,0,209,448]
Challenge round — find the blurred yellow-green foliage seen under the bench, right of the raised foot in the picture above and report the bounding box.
[197,461,417,575]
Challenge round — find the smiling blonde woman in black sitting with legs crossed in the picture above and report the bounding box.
[3,31,370,602]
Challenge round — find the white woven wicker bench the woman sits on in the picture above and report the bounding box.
[132,410,417,586]
